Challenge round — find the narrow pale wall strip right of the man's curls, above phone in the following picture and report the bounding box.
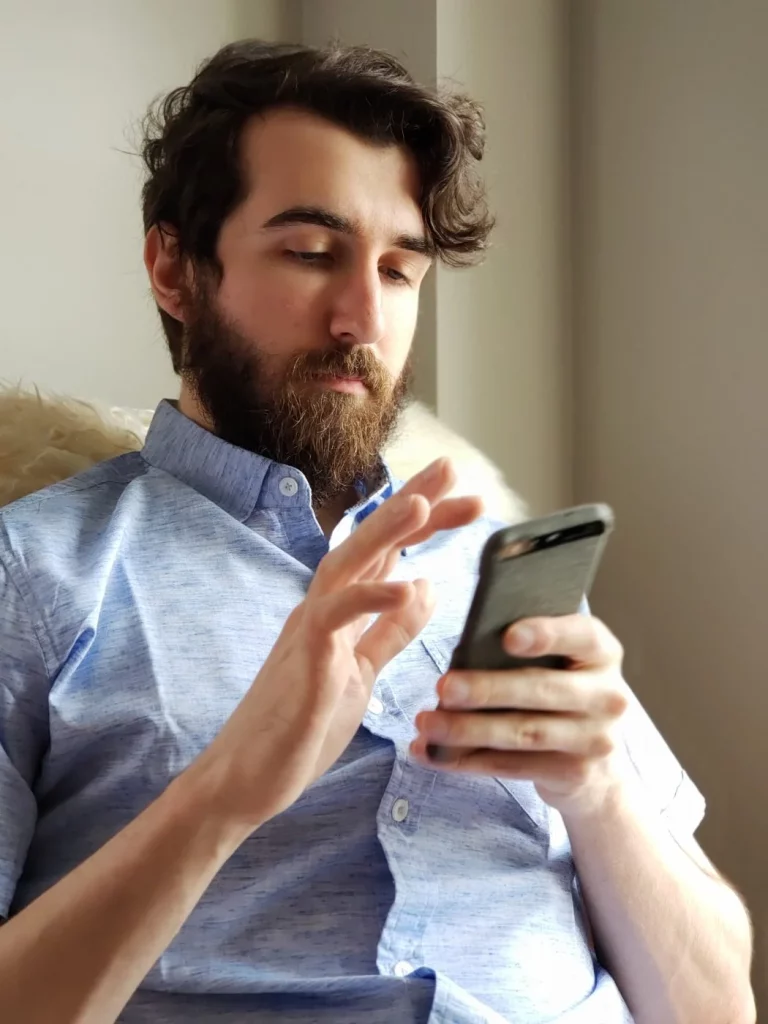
[437,0,571,512]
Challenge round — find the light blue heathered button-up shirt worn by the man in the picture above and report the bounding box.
[0,402,703,1024]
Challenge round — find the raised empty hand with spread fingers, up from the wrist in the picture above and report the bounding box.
[183,459,481,830]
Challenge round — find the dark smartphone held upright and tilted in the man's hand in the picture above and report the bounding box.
[428,505,613,761]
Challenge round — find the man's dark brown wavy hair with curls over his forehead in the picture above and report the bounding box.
[141,39,493,372]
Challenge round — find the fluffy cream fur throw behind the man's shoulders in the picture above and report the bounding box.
[0,388,525,522]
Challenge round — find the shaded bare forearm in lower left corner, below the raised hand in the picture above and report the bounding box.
[0,775,253,1024]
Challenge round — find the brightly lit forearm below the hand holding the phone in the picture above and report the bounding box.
[565,782,755,1024]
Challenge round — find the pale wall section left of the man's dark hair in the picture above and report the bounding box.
[0,0,299,406]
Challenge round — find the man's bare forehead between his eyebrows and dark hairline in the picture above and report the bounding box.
[234,109,424,238]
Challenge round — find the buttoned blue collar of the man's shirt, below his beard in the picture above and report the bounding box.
[141,399,393,522]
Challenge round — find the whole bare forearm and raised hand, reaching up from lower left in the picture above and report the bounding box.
[0,462,479,1024]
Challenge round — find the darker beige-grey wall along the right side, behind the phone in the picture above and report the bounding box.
[573,0,768,1013]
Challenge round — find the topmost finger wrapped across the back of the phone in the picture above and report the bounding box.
[504,614,624,668]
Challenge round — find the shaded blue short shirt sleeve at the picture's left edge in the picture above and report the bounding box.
[0,559,49,918]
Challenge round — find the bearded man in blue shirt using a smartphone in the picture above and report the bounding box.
[0,42,754,1024]
